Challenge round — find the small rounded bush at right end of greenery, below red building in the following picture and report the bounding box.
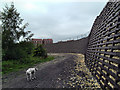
[33,45,47,58]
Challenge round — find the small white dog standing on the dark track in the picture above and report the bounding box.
[26,68,38,81]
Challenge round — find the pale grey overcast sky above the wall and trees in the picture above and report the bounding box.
[0,0,107,42]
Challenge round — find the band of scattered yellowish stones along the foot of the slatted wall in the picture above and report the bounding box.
[64,54,101,89]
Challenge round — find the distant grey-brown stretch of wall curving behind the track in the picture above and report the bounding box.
[44,37,88,54]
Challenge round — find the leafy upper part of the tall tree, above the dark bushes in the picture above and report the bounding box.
[0,3,33,49]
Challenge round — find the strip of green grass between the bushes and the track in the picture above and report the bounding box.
[2,56,54,75]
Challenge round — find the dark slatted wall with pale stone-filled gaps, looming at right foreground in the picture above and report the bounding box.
[85,2,120,89]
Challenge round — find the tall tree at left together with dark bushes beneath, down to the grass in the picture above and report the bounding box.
[0,3,33,60]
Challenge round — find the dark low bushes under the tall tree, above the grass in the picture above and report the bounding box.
[2,41,34,60]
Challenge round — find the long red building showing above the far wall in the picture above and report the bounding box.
[32,39,53,45]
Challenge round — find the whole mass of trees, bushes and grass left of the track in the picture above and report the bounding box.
[0,3,54,74]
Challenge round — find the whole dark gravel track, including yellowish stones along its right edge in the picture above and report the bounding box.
[2,54,100,88]
